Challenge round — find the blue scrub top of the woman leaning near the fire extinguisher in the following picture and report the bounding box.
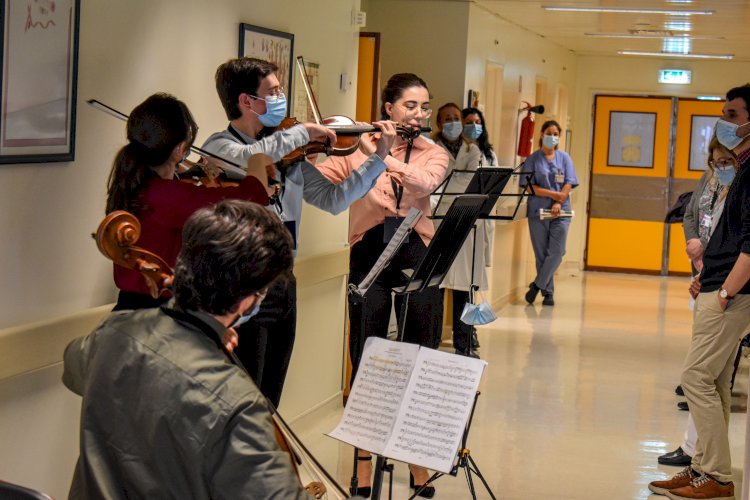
[519,149,578,219]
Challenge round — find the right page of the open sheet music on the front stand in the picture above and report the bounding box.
[384,349,487,474]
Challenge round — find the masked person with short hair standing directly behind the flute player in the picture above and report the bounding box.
[432,102,489,358]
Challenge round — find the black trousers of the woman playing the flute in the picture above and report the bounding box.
[349,225,443,381]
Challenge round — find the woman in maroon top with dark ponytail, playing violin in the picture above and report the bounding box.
[107,93,268,310]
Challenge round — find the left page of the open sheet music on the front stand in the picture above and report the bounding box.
[328,337,420,455]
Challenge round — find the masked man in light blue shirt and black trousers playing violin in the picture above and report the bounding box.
[203,57,396,406]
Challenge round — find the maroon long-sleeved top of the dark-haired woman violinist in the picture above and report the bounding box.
[114,176,268,295]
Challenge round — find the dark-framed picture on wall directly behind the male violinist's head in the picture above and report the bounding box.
[240,23,294,115]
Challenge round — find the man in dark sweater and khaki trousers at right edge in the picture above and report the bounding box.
[649,84,750,500]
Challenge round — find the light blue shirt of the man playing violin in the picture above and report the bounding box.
[203,125,386,248]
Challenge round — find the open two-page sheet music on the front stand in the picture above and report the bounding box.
[329,338,486,473]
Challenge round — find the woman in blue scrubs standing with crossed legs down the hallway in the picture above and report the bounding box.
[519,120,578,306]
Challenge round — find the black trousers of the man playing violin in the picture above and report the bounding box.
[234,272,297,408]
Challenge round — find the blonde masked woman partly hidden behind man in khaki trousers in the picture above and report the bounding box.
[658,137,737,466]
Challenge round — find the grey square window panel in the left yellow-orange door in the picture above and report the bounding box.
[607,111,656,168]
